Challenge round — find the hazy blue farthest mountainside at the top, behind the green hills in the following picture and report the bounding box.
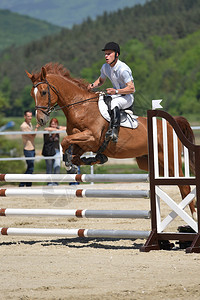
[0,0,147,28]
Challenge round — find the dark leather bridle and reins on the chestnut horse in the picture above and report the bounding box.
[33,79,99,116]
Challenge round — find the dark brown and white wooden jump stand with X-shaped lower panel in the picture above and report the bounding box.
[140,110,200,253]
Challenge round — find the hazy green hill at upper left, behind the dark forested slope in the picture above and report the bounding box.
[0,10,61,51]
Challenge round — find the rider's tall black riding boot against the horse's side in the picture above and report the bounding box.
[106,106,120,143]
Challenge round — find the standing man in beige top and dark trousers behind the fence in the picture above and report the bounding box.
[19,110,40,187]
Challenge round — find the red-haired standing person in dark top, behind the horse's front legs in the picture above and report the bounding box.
[42,118,66,185]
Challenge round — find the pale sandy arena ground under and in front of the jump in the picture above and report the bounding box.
[0,183,200,300]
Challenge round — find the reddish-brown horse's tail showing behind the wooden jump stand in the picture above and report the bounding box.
[175,116,195,174]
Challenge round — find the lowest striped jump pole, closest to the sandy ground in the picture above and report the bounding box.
[0,228,150,239]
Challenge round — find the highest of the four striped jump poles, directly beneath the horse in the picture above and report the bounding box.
[0,174,148,182]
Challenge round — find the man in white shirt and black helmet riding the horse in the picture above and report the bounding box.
[88,42,135,143]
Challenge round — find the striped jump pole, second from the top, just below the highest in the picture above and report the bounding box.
[0,188,149,198]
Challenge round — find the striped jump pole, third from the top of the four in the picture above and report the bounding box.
[0,208,151,219]
